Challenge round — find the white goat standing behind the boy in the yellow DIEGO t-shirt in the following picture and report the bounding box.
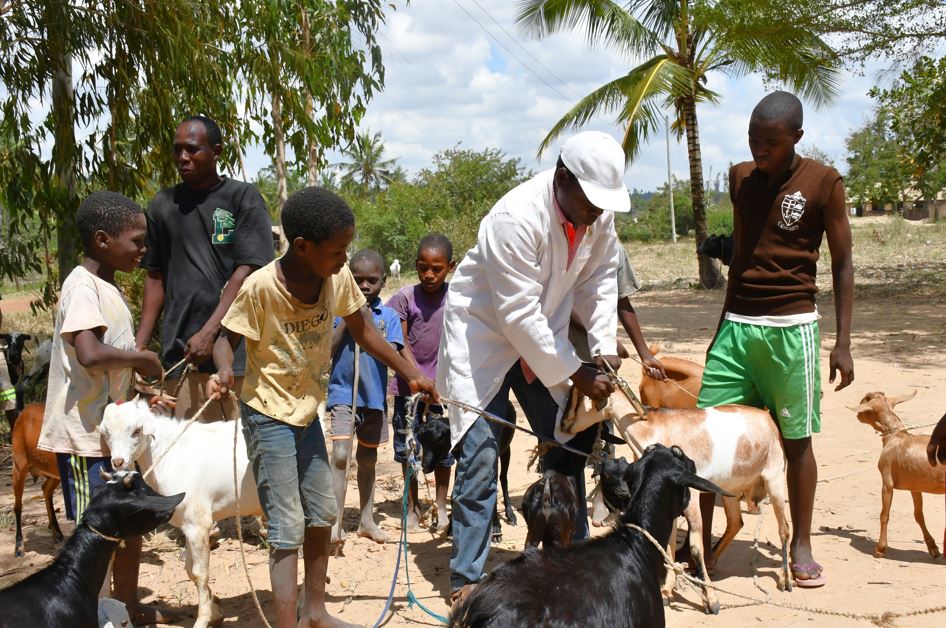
[99,397,262,628]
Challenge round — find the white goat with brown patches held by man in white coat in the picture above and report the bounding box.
[562,392,791,613]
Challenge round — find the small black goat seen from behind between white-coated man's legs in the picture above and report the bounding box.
[522,469,578,549]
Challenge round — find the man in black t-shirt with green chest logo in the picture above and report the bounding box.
[135,116,273,420]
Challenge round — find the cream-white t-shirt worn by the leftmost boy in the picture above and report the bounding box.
[39,266,135,457]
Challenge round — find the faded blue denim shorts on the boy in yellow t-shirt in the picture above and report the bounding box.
[240,402,338,549]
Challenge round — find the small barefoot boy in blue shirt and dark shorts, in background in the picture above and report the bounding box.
[325,249,404,543]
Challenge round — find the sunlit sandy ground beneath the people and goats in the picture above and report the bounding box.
[0,290,946,626]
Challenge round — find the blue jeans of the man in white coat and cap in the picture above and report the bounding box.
[450,361,597,590]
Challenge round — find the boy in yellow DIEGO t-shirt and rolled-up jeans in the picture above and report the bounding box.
[207,187,437,628]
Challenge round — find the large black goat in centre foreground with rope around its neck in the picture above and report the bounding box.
[450,445,725,628]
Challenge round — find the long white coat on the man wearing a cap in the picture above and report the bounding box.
[437,170,618,446]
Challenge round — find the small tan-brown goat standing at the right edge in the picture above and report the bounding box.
[850,390,946,558]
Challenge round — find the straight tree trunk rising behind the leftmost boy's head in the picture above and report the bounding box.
[46,2,79,286]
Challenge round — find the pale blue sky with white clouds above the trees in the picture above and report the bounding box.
[247,0,884,191]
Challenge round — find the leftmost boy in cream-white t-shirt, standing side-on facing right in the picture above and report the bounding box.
[39,192,166,624]
